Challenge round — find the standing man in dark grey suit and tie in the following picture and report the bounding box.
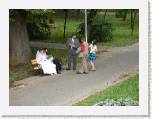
[66,35,80,70]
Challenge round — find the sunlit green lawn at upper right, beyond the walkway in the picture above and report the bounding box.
[99,15,139,47]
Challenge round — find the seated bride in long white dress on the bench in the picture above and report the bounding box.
[36,48,57,75]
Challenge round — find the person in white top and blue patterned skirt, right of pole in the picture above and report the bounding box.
[89,40,97,71]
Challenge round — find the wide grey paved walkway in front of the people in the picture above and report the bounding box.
[10,44,139,106]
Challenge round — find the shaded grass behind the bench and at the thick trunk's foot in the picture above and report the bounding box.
[9,48,67,82]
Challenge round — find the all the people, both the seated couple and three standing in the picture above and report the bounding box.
[36,35,97,75]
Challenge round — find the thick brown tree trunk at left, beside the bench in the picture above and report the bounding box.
[9,10,31,66]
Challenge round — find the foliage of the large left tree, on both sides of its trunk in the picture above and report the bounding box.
[9,9,54,39]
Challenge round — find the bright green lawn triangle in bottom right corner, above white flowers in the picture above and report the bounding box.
[74,74,139,106]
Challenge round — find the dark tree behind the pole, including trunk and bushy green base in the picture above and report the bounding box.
[78,10,113,42]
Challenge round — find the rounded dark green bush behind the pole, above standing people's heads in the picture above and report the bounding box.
[77,18,113,42]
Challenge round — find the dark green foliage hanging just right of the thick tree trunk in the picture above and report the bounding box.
[27,9,53,39]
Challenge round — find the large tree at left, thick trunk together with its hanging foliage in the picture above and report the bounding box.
[9,9,53,65]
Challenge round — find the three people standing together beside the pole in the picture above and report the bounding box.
[66,35,97,74]
